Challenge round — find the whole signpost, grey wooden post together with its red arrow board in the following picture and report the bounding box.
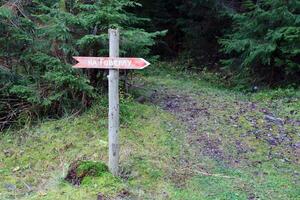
[73,29,150,176]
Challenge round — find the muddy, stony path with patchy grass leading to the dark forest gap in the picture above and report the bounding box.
[131,73,300,199]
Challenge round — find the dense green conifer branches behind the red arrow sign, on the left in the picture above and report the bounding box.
[0,0,162,129]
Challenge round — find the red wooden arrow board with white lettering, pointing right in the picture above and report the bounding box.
[73,57,150,69]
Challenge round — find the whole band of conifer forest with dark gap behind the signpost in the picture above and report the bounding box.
[0,0,300,129]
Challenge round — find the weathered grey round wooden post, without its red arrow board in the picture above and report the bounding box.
[108,29,120,176]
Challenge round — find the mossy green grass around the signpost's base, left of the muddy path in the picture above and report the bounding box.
[0,96,183,200]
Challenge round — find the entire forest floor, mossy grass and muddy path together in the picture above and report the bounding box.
[0,63,300,200]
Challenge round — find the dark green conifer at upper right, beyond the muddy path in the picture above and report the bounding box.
[220,0,300,85]
